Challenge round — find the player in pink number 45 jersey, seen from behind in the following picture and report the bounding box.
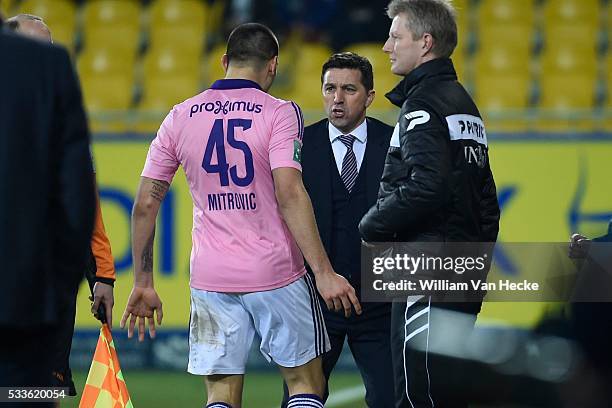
[121,23,361,408]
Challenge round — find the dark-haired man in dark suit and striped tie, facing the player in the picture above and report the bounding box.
[285,53,393,408]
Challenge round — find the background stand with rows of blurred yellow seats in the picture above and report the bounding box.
[2,0,612,132]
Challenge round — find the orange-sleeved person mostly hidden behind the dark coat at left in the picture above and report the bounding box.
[7,14,115,396]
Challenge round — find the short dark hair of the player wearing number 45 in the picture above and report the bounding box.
[226,23,278,69]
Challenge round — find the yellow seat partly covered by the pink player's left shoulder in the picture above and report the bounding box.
[132,76,201,133]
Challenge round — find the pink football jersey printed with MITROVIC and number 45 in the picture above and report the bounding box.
[142,79,305,292]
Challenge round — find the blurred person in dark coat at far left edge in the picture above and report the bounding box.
[0,17,96,396]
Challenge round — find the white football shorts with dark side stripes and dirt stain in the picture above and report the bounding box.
[187,274,330,375]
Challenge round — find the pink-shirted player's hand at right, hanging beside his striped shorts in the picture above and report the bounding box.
[316,272,361,317]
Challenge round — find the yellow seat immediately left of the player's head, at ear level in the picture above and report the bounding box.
[143,47,200,77]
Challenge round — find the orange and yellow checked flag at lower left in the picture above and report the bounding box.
[79,324,134,408]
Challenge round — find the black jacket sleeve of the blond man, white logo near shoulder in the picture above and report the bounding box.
[359,101,451,242]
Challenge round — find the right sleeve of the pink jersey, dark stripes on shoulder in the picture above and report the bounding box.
[269,102,304,171]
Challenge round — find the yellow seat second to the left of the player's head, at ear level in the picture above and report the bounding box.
[77,47,135,77]
